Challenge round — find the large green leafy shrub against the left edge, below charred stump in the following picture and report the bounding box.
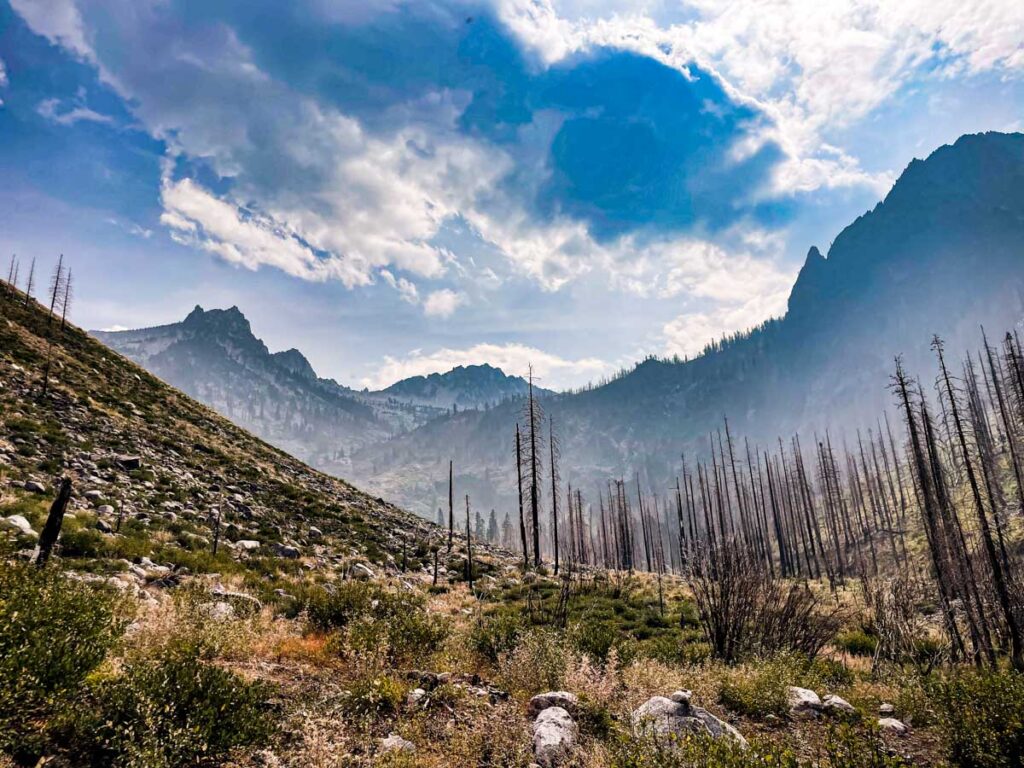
[0,563,125,757]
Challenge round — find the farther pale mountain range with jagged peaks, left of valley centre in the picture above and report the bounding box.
[91,306,544,475]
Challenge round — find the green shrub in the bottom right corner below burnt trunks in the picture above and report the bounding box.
[931,670,1024,768]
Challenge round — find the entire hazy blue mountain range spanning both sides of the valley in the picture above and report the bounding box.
[96,133,1024,516]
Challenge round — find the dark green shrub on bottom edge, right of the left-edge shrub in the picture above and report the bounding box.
[68,644,272,768]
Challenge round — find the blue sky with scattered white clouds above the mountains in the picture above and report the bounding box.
[0,0,1024,389]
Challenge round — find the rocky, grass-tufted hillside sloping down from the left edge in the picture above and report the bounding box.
[0,286,456,581]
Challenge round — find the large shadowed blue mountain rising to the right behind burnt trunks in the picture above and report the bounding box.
[353,133,1024,515]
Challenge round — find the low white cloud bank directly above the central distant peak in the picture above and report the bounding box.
[362,344,612,389]
